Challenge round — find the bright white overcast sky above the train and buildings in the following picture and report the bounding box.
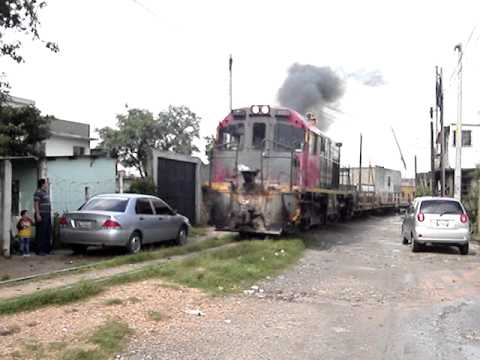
[0,0,480,176]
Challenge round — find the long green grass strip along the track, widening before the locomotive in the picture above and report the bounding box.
[0,238,305,315]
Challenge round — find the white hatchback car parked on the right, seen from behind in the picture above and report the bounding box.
[402,197,470,255]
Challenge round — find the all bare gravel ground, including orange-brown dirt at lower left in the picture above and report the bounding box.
[0,216,480,360]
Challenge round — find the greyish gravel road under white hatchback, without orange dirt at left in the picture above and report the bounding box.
[125,216,480,360]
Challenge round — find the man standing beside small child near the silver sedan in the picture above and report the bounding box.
[33,179,52,256]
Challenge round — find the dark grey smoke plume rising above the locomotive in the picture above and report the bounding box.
[277,63,345,130]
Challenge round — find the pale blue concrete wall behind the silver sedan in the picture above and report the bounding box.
[48,157,116,214]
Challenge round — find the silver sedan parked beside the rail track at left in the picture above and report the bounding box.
[59,194,190,253]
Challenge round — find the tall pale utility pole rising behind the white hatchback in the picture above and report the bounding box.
[454,44,463,200]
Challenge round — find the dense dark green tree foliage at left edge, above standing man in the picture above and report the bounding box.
[0,106,53,156]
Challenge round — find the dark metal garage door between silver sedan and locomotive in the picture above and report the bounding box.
[157,157,196,224]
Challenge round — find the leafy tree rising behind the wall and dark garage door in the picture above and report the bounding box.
[97,106,200,178]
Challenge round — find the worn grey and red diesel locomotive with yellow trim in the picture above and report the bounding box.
[207,105,354,234]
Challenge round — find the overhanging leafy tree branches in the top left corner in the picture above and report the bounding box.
[0,0,58,100]
